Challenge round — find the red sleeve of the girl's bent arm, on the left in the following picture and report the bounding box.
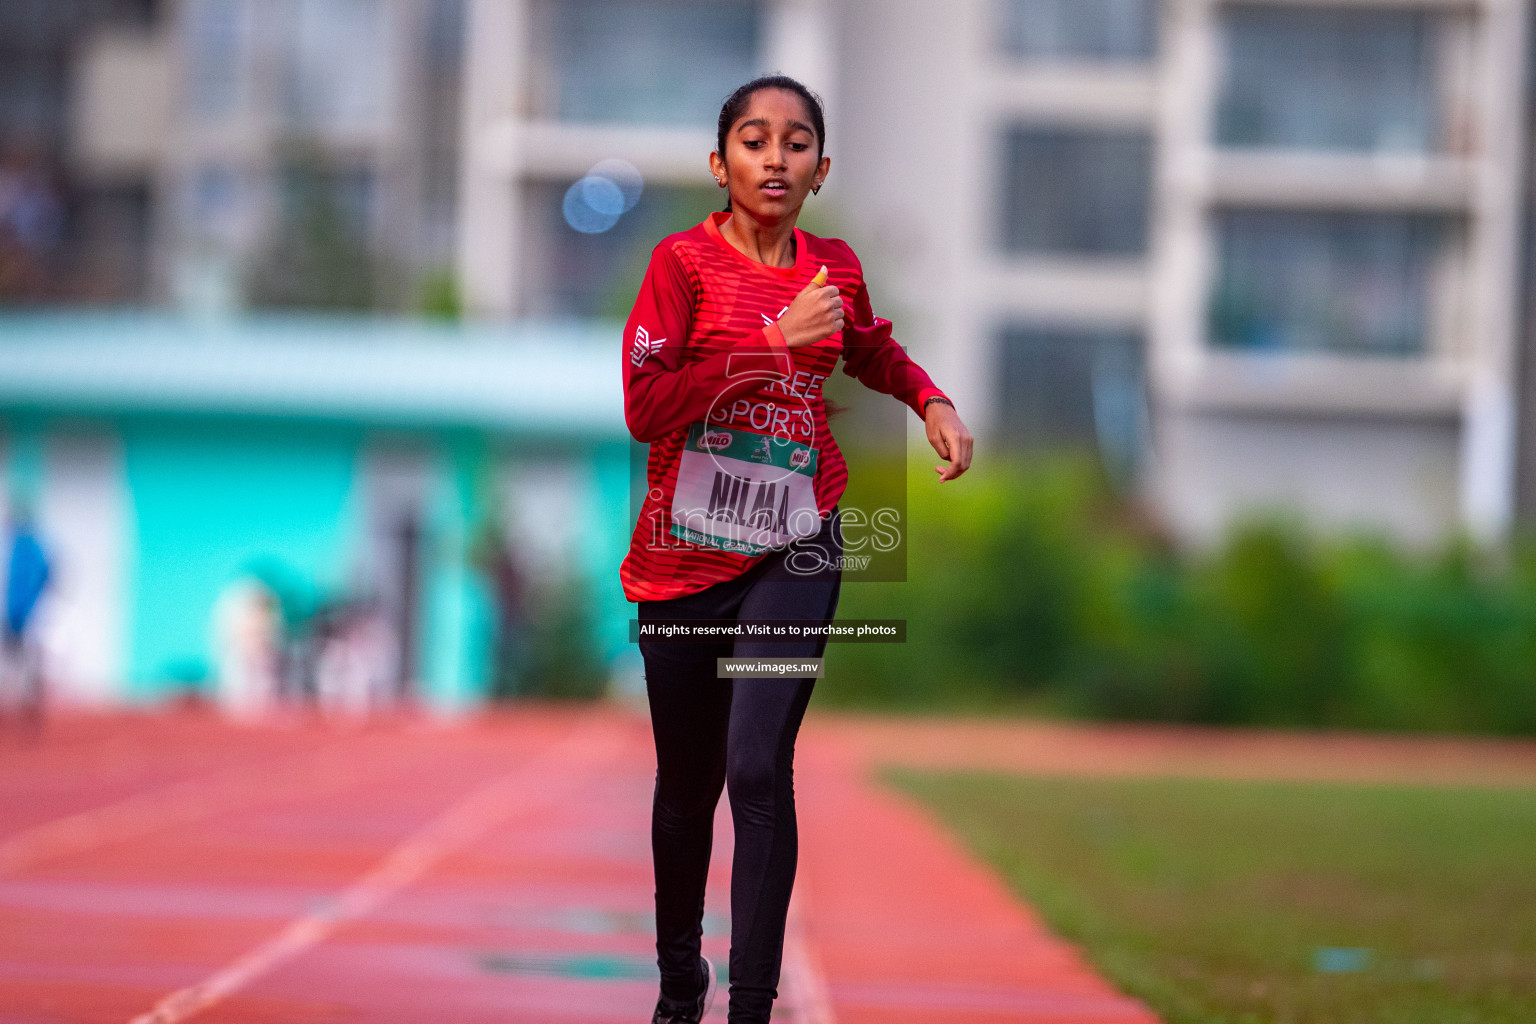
[624,243,794,442]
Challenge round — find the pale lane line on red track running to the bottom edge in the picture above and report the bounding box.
[131,723,622,1024]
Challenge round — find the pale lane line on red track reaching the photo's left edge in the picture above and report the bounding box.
[0,740,414,875]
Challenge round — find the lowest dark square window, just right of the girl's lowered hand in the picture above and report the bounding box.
[997,325,1147,479]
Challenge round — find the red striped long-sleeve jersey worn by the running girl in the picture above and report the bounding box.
[619,212,943,600]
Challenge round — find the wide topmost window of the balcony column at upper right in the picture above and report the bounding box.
[1217,6,1444,152]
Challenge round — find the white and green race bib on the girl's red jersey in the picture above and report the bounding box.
[671,422,822,554]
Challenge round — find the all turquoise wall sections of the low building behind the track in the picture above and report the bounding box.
[16,418,617,711]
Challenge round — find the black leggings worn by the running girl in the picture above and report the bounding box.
[639,510,842,1024]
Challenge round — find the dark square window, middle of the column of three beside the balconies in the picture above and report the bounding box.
[1001,127,1152,256]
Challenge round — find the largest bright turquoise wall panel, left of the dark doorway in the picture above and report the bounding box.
[124,422,359,700]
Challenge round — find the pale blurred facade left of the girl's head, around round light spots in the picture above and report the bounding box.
[458,0,839,319]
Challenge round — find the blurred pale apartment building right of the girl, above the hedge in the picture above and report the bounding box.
[834,0,1528,542]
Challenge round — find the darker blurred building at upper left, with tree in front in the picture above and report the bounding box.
[0,0,464,309]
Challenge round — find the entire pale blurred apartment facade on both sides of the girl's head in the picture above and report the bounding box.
[459,0,1530,542]
